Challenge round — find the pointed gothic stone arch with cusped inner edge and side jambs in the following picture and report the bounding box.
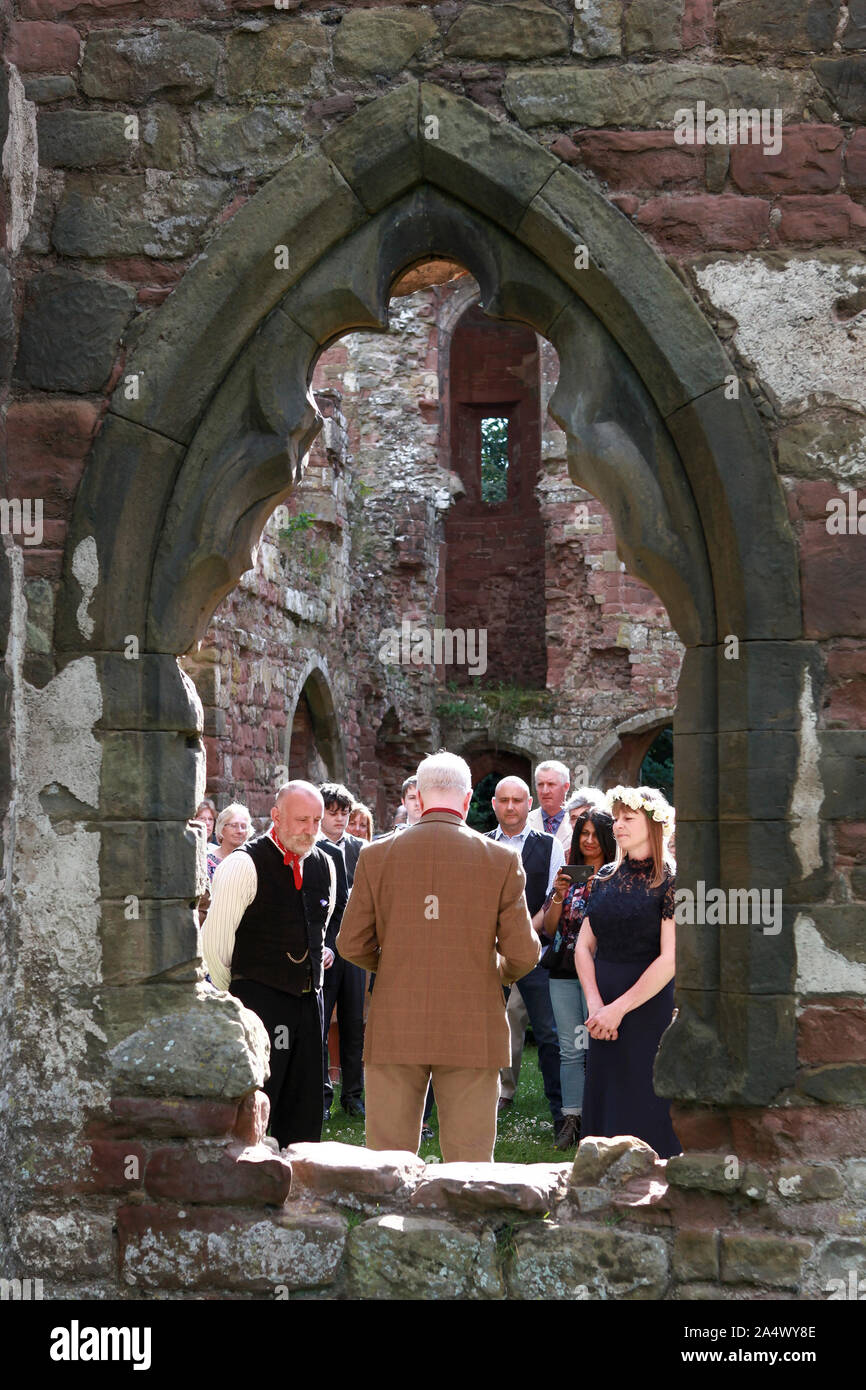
[57,82,820,1113]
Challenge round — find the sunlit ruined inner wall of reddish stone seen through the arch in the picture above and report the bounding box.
[183,278,683,826]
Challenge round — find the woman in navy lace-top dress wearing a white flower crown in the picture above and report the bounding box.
[574,787,683,1158]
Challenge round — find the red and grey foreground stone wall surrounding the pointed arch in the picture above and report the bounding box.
[0,0,866,1298]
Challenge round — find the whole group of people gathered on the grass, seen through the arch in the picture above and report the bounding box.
[200,751,680,1162]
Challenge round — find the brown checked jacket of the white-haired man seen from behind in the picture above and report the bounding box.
[336,810,541,1068]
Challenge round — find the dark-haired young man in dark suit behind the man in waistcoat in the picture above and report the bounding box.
[318,783,366,1120]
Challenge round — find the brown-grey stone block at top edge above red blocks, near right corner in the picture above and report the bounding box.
[716,0,840,58]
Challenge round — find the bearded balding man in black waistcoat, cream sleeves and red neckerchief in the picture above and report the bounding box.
[202,781,336,1148]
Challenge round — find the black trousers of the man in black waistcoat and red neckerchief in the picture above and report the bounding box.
[231,980,321,1148]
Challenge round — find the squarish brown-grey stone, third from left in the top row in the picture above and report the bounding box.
[225,19,330,96]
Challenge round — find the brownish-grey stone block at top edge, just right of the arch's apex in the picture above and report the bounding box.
[447,0,570,58]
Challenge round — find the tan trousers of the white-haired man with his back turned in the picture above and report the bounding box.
[364,1062,499,1163]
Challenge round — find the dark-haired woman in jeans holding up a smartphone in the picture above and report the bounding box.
[542,806,616,1150]
